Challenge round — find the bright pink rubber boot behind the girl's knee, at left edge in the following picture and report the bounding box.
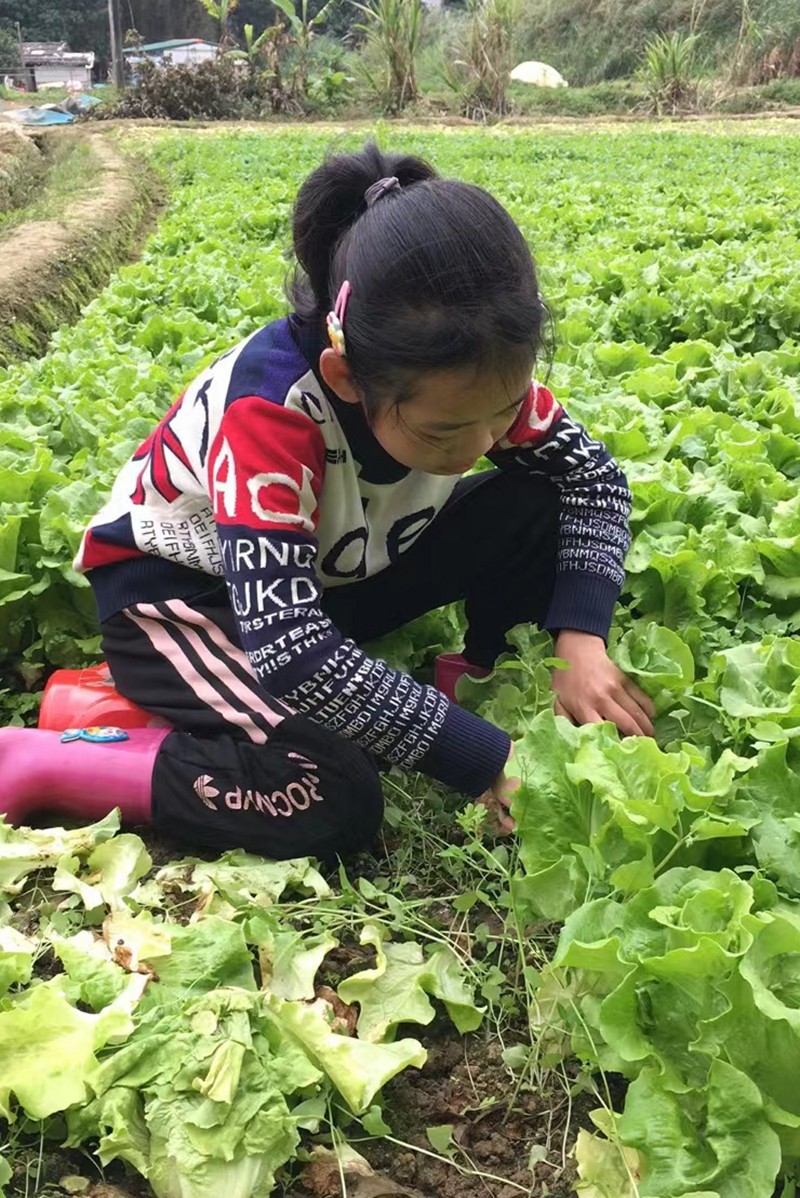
[0,728,170,824]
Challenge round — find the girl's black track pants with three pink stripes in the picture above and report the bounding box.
[103,471,558,858]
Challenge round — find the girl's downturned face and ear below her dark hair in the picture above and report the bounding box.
[321,350,533,474]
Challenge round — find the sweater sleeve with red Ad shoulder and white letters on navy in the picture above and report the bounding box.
[208,397,510,795]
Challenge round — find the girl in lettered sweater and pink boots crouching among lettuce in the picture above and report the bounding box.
[0,144,651,858]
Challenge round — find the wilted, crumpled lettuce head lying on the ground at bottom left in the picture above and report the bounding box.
[67,988,311,1198]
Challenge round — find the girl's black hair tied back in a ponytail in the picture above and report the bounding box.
[290,143,549,417]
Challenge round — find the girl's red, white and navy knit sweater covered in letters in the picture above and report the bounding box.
[75,317,630,794]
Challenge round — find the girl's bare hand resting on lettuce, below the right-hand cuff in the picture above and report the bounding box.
[553,630,655,737]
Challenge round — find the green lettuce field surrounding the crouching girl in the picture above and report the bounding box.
[0,127,800,1198]
